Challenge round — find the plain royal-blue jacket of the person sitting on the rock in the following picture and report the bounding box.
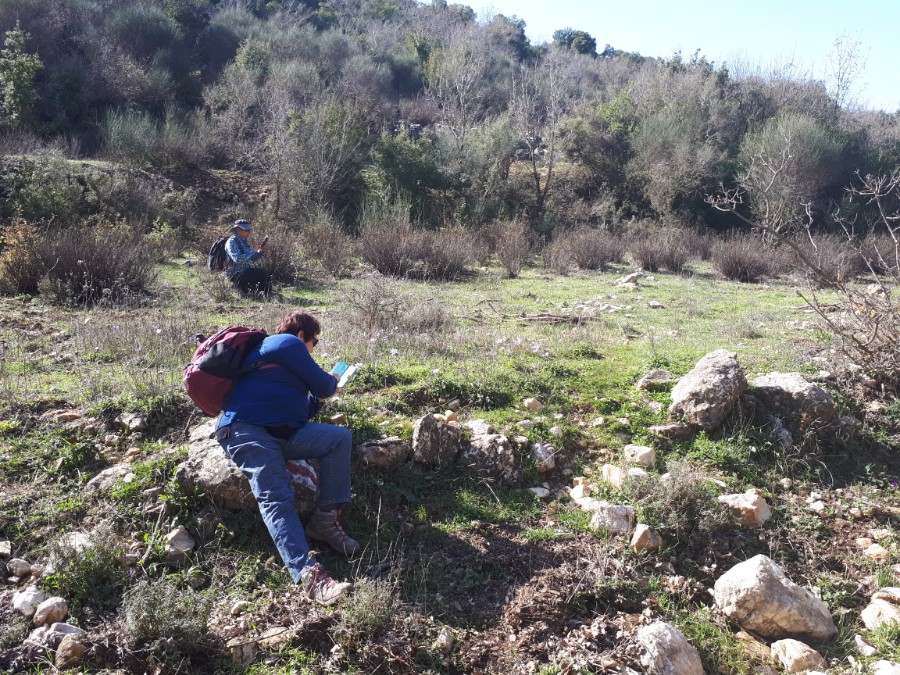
[216,335,337,428]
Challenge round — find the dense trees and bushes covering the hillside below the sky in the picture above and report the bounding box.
[0,0,900,235]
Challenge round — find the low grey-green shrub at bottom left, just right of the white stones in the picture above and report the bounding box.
[122,579,212,653]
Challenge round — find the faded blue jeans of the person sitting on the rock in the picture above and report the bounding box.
[216,422,353,583]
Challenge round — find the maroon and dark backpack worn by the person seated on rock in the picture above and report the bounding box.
[182,326,268,417]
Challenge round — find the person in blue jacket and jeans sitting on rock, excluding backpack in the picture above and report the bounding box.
[216,311,360,605]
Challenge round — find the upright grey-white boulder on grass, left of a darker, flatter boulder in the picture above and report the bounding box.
[669,349,747,431]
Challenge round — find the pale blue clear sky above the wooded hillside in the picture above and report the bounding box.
[460,0,900,112]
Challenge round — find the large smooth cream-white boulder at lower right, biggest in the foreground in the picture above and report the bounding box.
[713,555,837,643]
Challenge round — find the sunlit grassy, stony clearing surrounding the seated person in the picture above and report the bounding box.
[0,262,900,673]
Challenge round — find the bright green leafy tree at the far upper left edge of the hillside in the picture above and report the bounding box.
[0,21,44,126]
